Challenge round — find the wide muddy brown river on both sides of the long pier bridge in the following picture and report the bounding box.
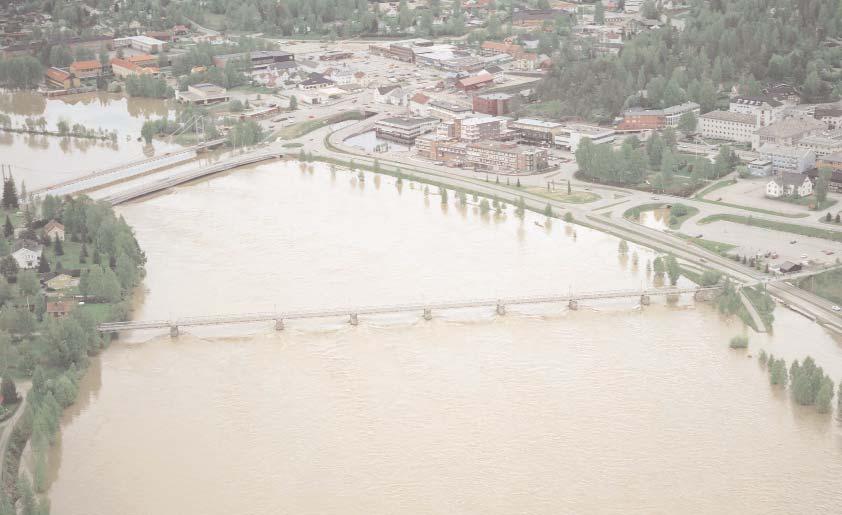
[49,162,842,515]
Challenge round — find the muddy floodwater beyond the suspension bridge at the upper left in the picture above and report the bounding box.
[0,92,181,190]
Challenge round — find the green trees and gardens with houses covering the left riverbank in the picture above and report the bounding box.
[0,195,146,513]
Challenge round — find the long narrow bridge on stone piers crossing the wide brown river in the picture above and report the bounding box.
[97,286,721,337]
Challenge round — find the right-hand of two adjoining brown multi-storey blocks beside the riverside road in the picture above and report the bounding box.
[465,141,549,174]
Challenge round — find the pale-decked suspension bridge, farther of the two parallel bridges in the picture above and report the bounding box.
[31,138,227,197]
